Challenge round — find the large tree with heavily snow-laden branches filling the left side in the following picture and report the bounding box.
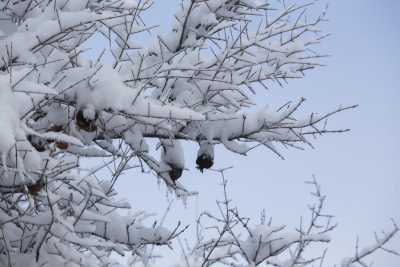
[0,0,364,266]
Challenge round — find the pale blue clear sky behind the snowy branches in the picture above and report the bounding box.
[95,0,400,267]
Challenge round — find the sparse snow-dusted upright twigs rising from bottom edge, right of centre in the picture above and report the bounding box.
[167,176,336,267]
